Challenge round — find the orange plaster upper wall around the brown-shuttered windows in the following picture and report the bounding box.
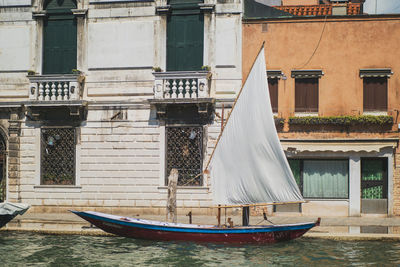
[242,17,400,117]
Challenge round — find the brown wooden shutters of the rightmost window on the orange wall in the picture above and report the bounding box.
[363,77,387,111]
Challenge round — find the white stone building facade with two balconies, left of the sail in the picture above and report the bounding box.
[0,0,242,217]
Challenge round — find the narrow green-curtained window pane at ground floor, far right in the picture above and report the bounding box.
[361,158,388,199]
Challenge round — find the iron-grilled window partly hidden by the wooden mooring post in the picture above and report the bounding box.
[165,126,203,186]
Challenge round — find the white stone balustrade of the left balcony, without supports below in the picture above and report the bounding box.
[28,74,84,101]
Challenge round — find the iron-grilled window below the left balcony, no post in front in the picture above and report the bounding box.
[40,128,76,185]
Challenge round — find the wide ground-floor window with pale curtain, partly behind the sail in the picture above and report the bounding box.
[289,159,349,199]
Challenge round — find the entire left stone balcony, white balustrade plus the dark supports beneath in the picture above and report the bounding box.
[24,74,86,118]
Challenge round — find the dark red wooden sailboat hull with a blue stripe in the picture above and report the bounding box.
[71,211,320,244]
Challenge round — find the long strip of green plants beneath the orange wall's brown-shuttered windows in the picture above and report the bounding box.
[289,115,393,126]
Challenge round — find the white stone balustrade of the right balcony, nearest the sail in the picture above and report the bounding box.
[153,71,210,99]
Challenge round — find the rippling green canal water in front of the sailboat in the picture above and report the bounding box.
[0,231,400,267]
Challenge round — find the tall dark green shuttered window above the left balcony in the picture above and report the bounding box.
[43,0,77,74]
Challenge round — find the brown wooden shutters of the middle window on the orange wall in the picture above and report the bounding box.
[295,78,318,112]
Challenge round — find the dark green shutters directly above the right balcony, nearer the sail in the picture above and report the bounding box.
[167,13,204,71]
